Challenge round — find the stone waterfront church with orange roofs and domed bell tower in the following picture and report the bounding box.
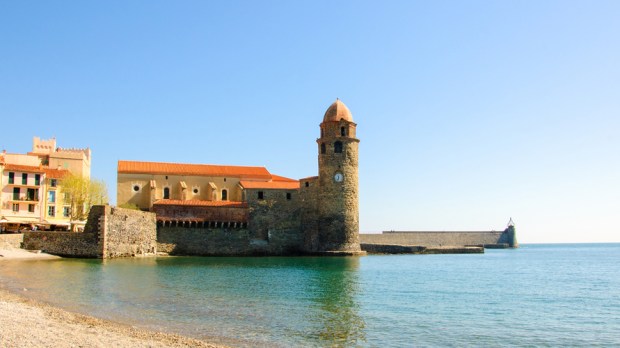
[117,100,364,255]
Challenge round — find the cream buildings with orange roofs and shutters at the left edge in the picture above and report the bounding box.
[0,137,91,231]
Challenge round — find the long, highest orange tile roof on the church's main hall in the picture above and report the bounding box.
[118,161,271,180]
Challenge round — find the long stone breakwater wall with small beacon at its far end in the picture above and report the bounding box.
[360,228,517,247]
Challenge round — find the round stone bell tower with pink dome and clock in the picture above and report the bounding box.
[317,100,363,254]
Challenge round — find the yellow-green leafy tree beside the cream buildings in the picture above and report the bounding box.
[60,173,108,221]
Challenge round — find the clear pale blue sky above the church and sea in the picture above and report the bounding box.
[0,0,620,243]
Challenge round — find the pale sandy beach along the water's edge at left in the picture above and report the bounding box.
[0,249,228,347]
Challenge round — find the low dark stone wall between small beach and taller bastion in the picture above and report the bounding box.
[23,232,101,258]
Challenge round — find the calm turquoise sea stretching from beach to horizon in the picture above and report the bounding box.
[0,244,620,347]
